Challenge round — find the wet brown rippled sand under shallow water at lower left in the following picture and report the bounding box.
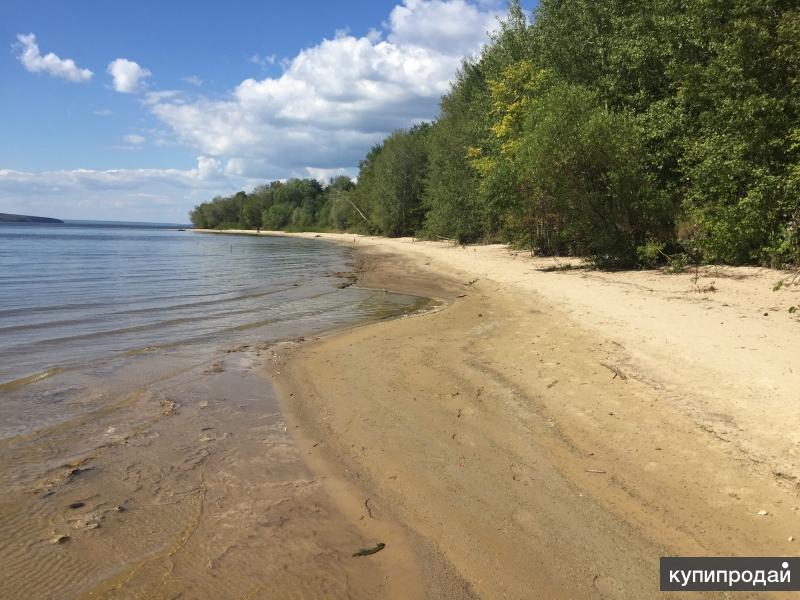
[0,341,472,599]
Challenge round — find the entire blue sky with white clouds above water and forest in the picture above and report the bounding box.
[0,0,505,223]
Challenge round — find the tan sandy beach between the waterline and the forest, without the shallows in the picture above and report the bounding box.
[206,229,800,598]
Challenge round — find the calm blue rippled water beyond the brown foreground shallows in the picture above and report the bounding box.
[0,225,416,394]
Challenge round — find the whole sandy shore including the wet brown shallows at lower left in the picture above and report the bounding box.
[6,231,800,599]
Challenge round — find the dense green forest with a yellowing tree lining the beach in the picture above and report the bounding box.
[191,0,800,268]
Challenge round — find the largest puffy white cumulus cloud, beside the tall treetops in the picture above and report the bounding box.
[150,0,498,177]
